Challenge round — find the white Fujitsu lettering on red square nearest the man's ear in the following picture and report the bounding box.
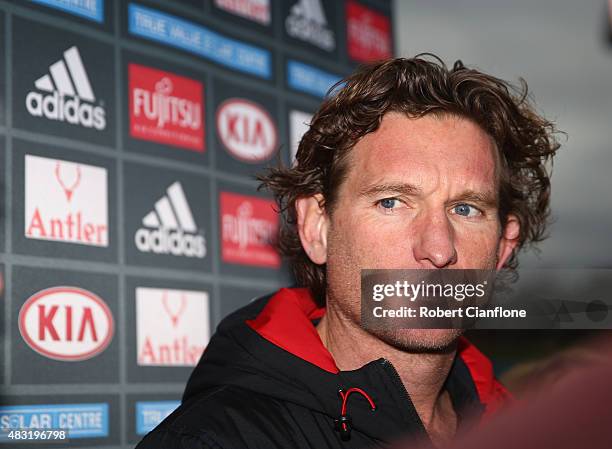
[223,201,277,249]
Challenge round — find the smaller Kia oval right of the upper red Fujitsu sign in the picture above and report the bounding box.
[217,98,278,163]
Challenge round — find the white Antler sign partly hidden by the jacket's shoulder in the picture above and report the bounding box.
[136,287,210,366]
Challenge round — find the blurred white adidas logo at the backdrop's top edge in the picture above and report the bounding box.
[285,0,336,51]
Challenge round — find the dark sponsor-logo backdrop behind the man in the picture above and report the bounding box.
[0,0,393,448]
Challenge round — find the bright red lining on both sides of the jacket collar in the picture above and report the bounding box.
[247,288,512,410]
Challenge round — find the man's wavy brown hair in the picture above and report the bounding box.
[258,54,559,304]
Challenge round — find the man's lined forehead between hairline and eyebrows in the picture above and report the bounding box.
[348,113,496,190]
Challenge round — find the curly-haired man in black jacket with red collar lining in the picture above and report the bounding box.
[139,57,558,449]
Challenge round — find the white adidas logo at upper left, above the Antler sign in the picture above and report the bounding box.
[26,46,106,131]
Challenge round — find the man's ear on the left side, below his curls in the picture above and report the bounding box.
[295,193,329,265]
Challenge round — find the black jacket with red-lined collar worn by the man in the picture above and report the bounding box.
[137,289,508,449]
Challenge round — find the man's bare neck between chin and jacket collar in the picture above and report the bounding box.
[317,305,456,435]
